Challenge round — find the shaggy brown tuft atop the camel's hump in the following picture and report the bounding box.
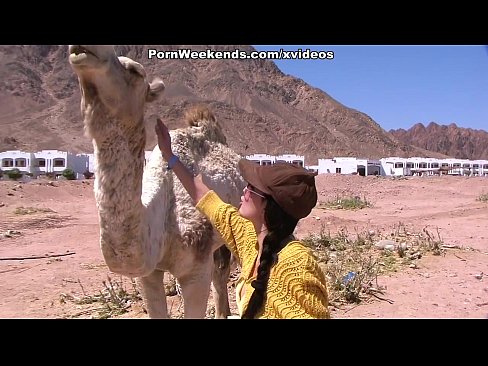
[185,104,227,144]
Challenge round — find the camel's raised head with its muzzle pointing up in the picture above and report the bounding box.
[69,45,164,128]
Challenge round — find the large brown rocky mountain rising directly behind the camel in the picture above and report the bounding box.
[0,45,450,164]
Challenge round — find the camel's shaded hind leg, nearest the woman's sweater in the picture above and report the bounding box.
[212,245,230,319]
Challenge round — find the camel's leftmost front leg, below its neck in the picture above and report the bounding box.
[136,270,168,319]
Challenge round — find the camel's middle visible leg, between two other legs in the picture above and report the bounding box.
[177,261,212,319]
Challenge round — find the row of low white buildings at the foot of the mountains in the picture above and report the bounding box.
[0,150,488,179]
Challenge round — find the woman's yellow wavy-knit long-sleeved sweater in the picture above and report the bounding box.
[196,191,329,318]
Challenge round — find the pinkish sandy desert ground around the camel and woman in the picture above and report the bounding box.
[0,175,488,318]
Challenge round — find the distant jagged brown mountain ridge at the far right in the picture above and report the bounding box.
[389,122,488,160]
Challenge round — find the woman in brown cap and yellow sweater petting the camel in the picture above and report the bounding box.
[156,118,329,319]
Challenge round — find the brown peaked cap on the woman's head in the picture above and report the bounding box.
[239,159,317,220]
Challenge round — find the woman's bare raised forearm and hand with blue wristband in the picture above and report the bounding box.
[156,118,209,204]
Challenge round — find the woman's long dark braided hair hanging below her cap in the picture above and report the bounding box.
[242,196,298,319]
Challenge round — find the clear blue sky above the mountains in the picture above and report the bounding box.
[254,45,488,131]
